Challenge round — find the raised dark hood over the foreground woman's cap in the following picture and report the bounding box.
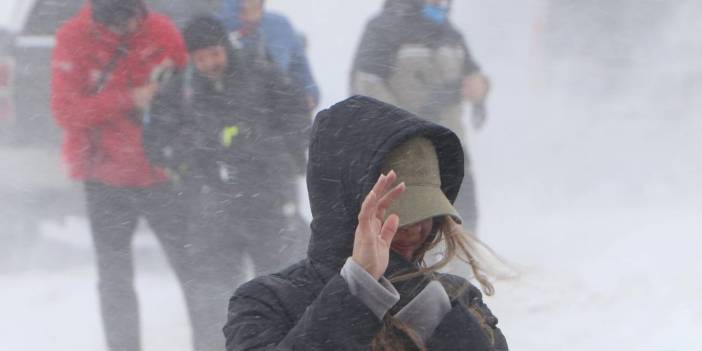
[307,96,463,269]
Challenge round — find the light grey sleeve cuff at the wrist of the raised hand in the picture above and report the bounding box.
[340,257,400,320]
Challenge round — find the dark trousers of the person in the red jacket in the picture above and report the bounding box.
[85,182,191,351]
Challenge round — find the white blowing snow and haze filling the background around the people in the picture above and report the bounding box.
[0,0,702,351]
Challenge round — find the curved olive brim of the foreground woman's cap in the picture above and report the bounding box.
[385,185,463,227]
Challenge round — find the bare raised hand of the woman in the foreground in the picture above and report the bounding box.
[352,171,405,279]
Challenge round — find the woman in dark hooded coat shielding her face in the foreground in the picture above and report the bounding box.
[223,96,507,351]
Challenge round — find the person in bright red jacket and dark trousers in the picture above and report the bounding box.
[51,0,194,351]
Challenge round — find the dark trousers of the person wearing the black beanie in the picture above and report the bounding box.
[188,164,309,351]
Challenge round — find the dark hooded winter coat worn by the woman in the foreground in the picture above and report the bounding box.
[224,97,507,351]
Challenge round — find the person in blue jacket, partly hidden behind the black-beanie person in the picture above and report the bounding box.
[220,0,320,111]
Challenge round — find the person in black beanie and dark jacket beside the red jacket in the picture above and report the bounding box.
[144,17,311,351]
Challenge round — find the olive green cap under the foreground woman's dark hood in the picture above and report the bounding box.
[381,137,462,230]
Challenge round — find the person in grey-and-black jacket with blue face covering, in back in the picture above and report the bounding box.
[351,0,488,235]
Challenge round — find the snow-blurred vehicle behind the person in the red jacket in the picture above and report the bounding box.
[0,0,219,265]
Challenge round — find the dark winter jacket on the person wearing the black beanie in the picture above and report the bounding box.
[145,41,311,190]
